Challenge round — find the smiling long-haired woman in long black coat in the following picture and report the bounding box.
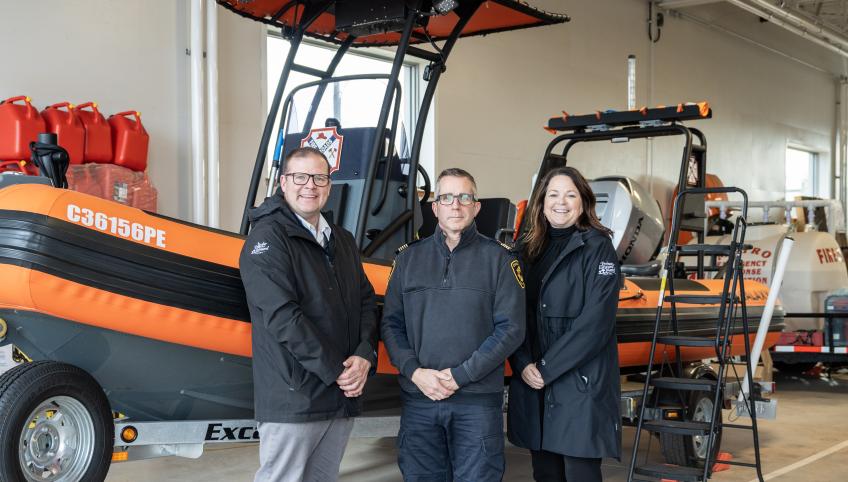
[507,167,621,482]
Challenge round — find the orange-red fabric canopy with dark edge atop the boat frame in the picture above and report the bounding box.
[217,0,571,47]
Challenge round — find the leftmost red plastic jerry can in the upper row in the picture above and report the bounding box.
[0,95,45,161]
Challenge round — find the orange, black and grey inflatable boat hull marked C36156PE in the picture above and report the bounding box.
[0,185,783,420]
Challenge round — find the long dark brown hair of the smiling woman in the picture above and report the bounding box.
[523,166,612,261]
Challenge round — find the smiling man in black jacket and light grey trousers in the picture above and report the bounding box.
[239,147,377,482]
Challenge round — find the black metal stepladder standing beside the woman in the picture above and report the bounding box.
[627,187,763,482]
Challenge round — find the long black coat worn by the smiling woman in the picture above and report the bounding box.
[507,229,621,459]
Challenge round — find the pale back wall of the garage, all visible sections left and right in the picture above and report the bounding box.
[0,0,836,230]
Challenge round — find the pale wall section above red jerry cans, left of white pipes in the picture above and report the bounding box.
[0,0,191,219]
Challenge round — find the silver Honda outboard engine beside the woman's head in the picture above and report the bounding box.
[589,176,665,265]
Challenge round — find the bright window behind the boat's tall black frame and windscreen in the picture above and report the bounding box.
[266,31,435,174]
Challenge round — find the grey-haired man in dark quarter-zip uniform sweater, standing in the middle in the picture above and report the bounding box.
[382,169,525,482]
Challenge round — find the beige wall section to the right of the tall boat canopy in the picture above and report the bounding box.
[436,0,836,213]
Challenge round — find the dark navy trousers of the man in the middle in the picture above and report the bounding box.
[398,401,505,482]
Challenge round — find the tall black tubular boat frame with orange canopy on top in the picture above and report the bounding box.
[217,0,570,253]
